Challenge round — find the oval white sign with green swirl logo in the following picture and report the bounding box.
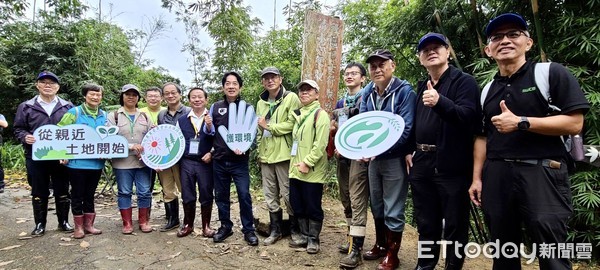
[335,111,404,159]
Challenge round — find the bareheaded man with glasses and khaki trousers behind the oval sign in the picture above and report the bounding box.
[331,62,370,268]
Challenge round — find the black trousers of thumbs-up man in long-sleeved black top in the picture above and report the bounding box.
[408,151,472,266]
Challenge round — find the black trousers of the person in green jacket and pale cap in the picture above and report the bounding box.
[290,178,324,222]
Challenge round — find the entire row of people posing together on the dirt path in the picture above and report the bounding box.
[9,13,589,270]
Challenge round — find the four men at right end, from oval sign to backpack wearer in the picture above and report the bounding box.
[331,13,589,270]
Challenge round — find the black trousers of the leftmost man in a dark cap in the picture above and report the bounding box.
[25,158,69,199]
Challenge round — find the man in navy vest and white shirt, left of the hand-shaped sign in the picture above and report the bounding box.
[177,87,215,238]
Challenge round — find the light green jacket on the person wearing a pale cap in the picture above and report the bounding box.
[290,100,329,183]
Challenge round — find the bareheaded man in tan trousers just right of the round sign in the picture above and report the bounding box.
[158,82,191,232]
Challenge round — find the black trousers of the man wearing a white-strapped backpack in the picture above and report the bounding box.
[481,160,573,270]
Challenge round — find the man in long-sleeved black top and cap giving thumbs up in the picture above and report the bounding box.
[406,33,481,270]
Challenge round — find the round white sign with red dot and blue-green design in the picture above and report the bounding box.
[142,125,185,169]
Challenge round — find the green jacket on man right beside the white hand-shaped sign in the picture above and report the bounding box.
[256,86,300,164]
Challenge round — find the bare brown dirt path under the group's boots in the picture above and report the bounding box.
[0,181,584,269]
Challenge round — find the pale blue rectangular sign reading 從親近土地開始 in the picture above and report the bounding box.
[31,124,129,160]
